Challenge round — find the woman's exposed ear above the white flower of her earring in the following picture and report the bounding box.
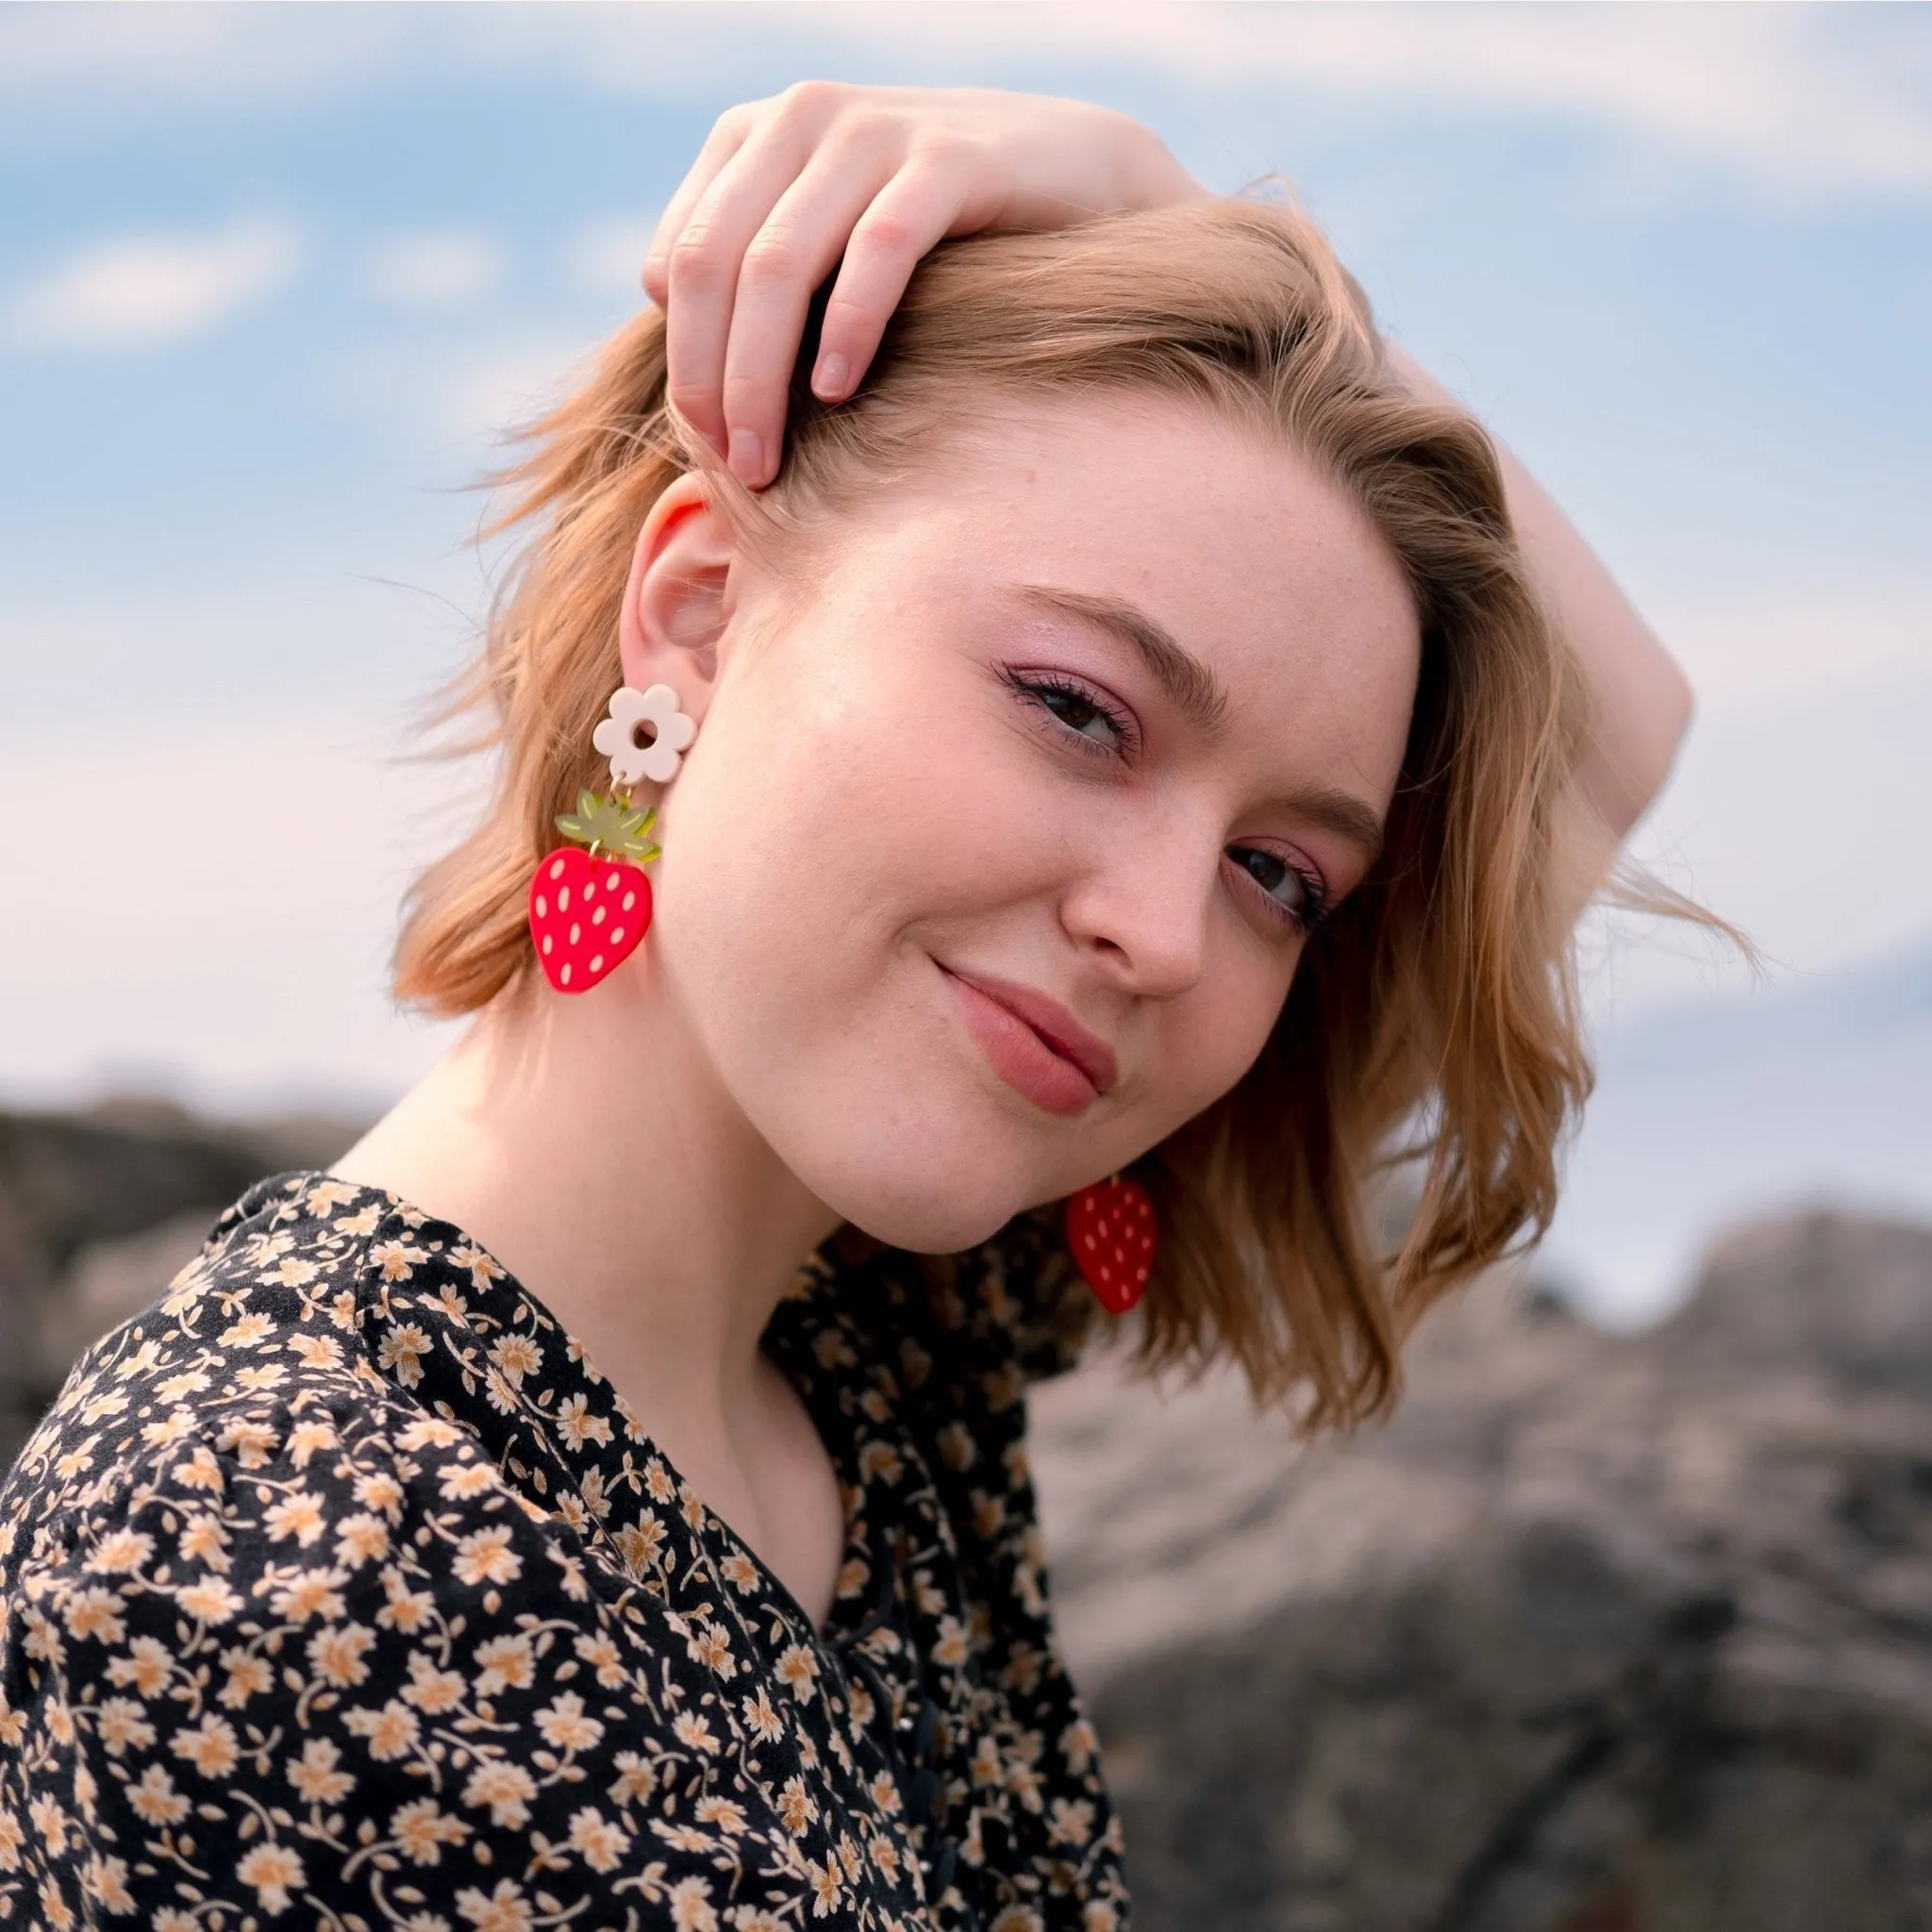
[618,475,738,719]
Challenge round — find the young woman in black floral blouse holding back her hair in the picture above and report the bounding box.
[0,87,1685,1932]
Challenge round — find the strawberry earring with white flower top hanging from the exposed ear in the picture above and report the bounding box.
[529,684,697,993]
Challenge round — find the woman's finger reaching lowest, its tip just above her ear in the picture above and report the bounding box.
[723,147,919,489]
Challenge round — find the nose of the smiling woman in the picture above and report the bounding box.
[1060,824,1221,999]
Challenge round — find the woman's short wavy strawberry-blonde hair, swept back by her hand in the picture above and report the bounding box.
[396,201,1591,1430]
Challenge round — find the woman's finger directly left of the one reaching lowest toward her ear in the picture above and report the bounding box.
[665,127,826,456]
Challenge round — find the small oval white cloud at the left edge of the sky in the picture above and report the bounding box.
[8,216,301,350]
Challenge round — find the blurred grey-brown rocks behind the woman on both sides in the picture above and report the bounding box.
[0,1105,1932,1932]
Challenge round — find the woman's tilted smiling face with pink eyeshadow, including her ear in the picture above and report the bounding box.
[625,396,1418,1250]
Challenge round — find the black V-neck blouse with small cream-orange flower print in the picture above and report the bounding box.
[0,1174,1126,1932]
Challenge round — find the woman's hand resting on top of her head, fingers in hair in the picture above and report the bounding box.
[643,81,1204,489]
